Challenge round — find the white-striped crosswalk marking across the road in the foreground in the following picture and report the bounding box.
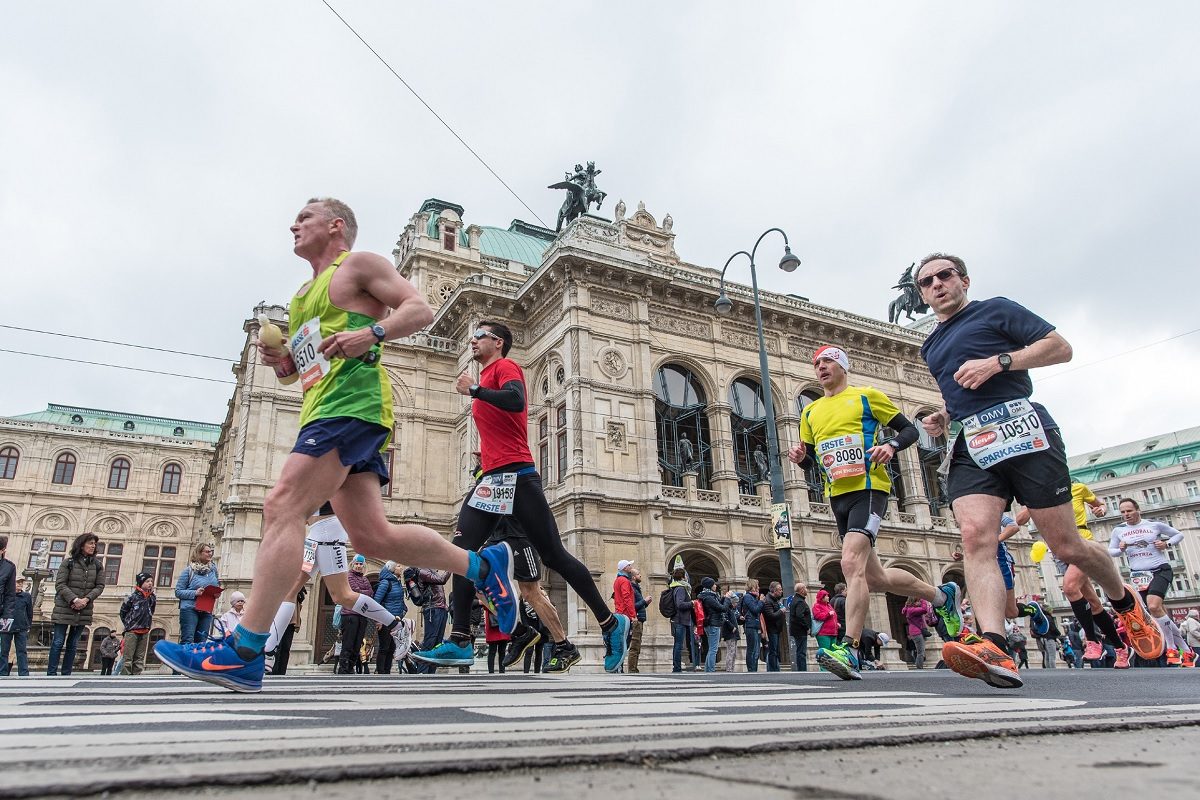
[0,675,1200,796]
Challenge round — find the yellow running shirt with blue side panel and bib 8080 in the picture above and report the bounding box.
[800,386,900,497]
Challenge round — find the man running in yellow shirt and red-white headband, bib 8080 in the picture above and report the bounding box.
[787,347,962,680]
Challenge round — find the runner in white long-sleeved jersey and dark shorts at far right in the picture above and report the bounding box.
[1109,498,1195,666]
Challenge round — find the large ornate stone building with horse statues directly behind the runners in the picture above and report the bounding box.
[200,199,1037,668]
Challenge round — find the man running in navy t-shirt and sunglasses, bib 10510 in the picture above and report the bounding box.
[917,253,1163,688]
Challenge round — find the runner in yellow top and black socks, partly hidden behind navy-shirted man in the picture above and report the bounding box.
[1016,481,1129,669]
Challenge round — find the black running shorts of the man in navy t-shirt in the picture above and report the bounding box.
[946,428,1070,509]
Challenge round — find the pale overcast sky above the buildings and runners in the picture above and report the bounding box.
[0,0,1200,453]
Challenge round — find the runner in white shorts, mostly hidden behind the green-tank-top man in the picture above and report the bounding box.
[265,503,413,664]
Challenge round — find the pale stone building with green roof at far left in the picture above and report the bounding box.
[0,404,218,667]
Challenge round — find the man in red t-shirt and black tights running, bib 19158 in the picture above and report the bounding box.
[413,320,629,672]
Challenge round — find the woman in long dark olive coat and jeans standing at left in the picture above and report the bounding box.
[46,534,104,675]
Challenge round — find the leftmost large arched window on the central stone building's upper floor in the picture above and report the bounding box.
[654,363,713,489]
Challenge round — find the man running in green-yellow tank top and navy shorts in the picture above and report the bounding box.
[155,198,517,692]
